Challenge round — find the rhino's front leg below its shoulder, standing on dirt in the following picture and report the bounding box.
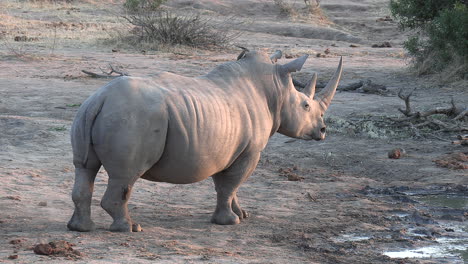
[211,152,260,225]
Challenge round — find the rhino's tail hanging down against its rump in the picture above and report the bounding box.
[70,94,104,168]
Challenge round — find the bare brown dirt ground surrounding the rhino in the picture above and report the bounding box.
[0,0,468,263]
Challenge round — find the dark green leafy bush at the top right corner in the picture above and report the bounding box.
[390,0,468,77]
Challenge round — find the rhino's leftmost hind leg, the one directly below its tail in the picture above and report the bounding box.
[67,166,99,232]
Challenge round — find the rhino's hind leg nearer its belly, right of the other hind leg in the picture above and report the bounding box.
[101,177,141,232]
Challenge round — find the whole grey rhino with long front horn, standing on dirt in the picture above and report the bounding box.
[68,52,342,232]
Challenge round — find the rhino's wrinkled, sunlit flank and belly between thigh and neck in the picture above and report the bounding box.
[139,73,271,183]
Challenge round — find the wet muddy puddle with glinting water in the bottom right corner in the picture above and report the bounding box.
[360,184,468,263]
